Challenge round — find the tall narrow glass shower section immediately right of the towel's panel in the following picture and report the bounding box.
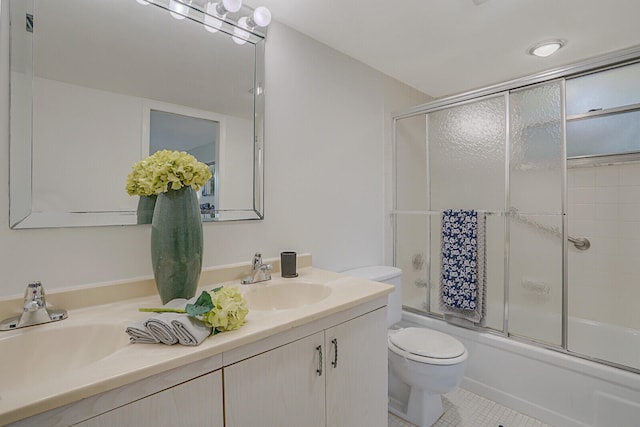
[508,80,566,346]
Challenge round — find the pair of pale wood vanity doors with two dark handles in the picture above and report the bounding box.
[224,308,387,427]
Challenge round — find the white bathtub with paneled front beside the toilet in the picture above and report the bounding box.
[401,312,640,427]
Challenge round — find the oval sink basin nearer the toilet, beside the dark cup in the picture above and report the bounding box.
[245,281,331,311]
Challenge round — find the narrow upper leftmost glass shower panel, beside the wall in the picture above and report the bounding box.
[396,115,427,210]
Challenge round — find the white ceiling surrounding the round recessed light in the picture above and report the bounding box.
[247,0,640,98]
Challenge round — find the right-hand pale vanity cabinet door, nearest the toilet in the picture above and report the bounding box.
[328,308,388,427]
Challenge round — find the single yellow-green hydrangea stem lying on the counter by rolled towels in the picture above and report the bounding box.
[139,286,249,335]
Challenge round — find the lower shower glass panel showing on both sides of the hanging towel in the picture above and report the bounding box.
[429,215,505,331]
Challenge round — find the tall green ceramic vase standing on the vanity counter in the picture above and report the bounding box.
[151,187,203,304]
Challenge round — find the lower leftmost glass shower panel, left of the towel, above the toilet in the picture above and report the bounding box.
[395,214,429,311]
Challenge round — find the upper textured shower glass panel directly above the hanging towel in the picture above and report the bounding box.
[428,96,506,211]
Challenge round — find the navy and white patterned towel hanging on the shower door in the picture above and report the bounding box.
[440,209,486,323]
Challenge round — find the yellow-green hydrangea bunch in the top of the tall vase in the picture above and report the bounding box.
[127,150,211,196]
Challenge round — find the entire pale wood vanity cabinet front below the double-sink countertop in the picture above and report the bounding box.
[7,297,387,427]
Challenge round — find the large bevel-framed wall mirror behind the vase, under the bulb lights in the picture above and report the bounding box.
[8,0,264,228]
